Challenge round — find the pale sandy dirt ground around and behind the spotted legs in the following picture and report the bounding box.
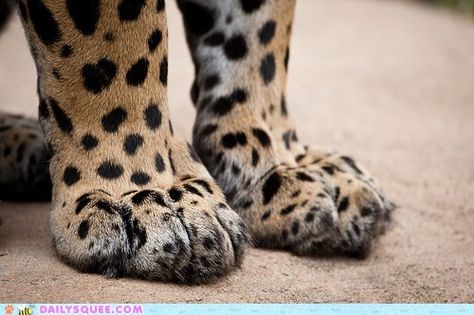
[0,0,474,303]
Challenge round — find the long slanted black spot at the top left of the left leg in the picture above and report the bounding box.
[27,0,61,46]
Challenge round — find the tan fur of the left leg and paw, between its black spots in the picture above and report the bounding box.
[15,1,247,282]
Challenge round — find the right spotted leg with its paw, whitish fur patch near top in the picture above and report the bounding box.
[178,0,389,255]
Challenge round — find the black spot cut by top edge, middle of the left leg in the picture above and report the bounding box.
[66,0,100,35]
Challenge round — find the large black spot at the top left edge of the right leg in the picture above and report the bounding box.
[178,1,215,36]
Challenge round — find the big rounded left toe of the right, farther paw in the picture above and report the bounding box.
[243,166,338,253]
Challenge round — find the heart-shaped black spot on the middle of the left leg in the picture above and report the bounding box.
[82,58,117,94]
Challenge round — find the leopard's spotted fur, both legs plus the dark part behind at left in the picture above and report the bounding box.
[0,0,393,283]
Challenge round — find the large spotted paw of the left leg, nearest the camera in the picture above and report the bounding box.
[52,178,249,283]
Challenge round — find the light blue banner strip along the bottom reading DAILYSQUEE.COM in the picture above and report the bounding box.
[0,303,474,315]
